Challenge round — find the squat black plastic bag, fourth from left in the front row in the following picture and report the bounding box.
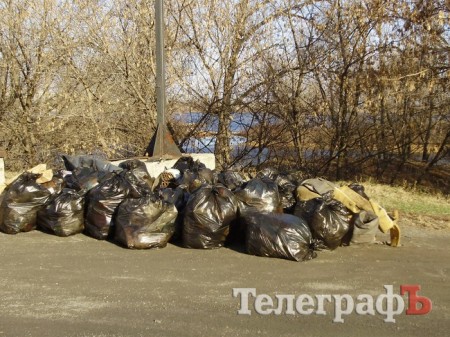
[115,195,178,249]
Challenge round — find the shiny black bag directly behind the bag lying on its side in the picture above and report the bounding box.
[234,177,283,215]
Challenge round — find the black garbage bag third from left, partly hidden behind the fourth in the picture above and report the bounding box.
[85,171,151,240]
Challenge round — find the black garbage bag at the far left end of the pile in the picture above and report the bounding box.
[0,172,51,234]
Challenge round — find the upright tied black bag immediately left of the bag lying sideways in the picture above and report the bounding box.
[183,185,238,249]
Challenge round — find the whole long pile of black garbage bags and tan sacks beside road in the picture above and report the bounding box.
[0,155,400,261]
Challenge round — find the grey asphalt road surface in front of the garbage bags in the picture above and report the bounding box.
[0,227,450,337]
